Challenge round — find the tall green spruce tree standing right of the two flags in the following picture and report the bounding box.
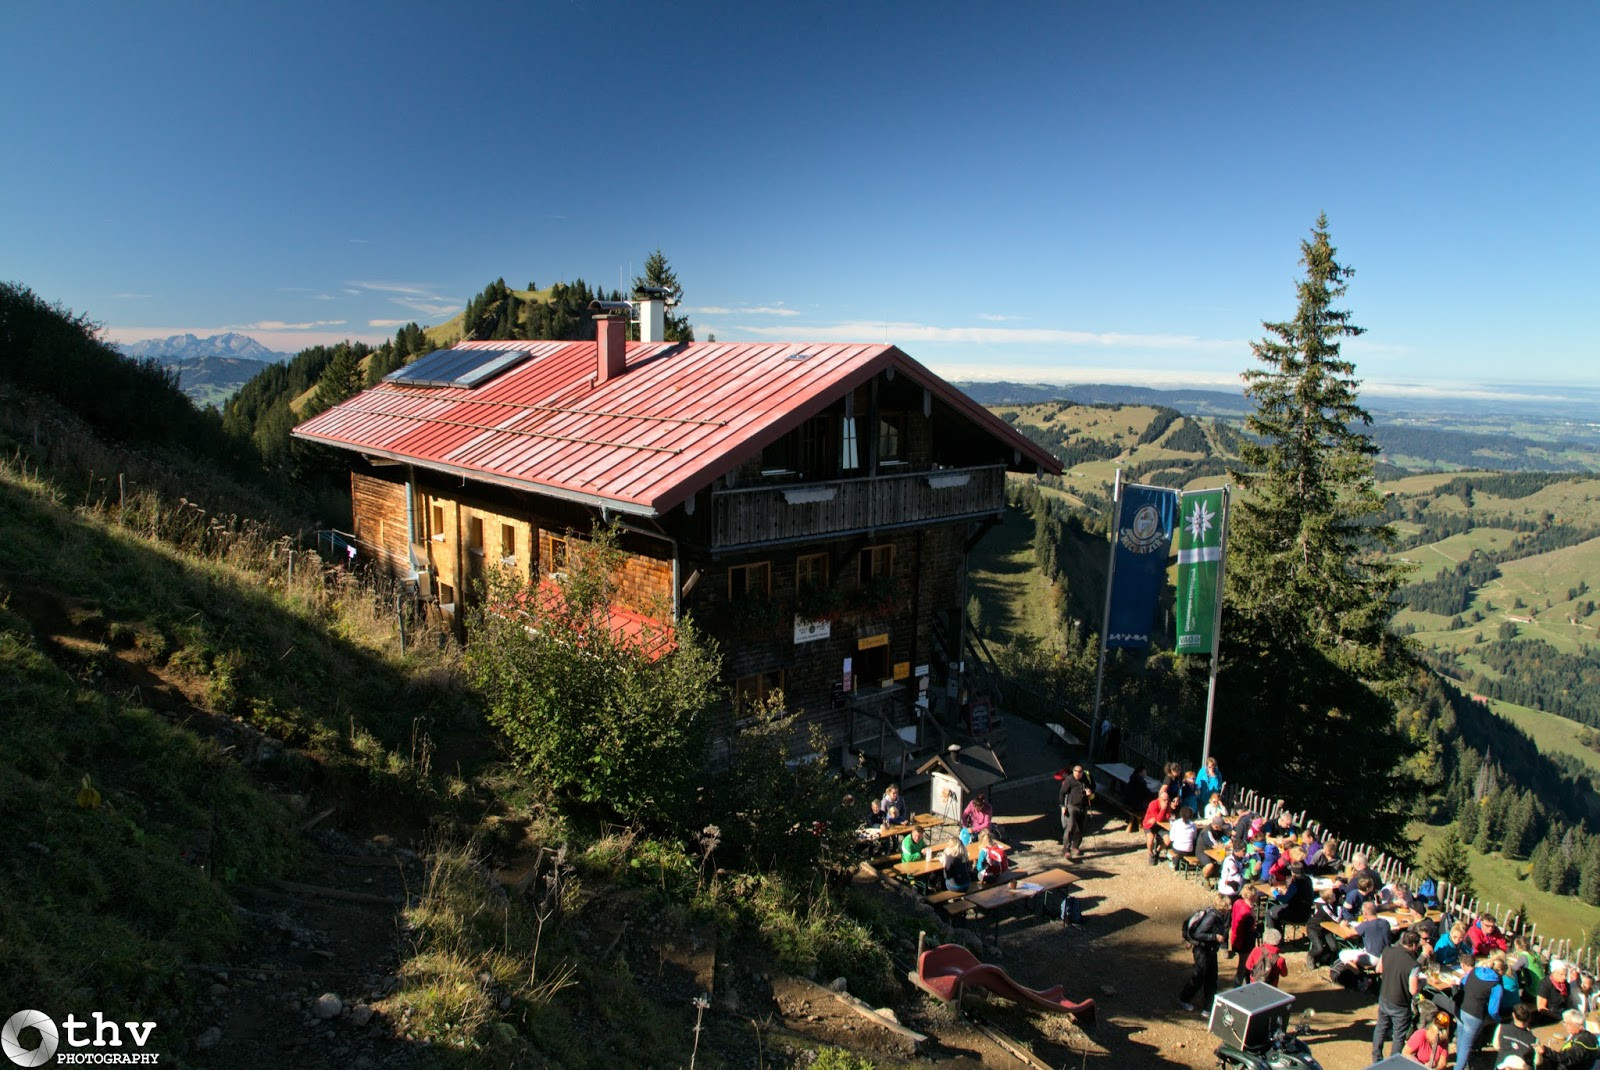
[1218,218,1416,849]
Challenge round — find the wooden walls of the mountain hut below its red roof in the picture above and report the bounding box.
[350,363,1018,739]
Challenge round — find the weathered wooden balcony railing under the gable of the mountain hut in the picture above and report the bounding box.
[710,464,1005,550]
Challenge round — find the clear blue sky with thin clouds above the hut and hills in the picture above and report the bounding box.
[0,0,1600,392]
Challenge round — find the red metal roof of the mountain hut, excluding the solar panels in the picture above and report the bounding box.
[294,335,1061,515]
